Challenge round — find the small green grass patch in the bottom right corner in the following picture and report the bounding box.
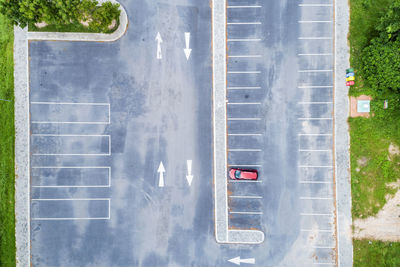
[354,240,400,267]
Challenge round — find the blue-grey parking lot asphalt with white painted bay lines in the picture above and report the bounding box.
[29,0,336,266]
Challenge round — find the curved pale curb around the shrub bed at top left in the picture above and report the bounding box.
[28,0,129,42]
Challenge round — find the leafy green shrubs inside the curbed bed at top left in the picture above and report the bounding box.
[0,0,120,32]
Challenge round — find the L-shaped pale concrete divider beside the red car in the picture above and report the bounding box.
[212,0,264,244]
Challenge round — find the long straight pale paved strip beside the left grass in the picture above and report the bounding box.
[14,26,30,266]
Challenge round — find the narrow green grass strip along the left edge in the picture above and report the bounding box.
[0,15,16,267]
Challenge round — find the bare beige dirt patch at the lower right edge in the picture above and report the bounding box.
[353,184,400,242]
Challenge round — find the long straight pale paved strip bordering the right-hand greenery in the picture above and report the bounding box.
[335,0,353,267]
